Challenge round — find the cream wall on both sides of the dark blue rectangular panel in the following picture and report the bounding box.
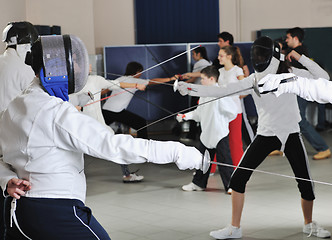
[0,0,332,54]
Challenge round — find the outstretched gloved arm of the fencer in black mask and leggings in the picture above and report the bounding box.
[177,74,254,97]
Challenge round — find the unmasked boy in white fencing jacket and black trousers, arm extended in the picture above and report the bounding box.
[177,66,237,194]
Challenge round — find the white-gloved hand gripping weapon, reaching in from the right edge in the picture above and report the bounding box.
[258,73,296,97]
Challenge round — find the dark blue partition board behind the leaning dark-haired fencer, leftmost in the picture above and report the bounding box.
[104,44,188,121]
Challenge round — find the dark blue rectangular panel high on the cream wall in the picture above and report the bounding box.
[135,0,219,44]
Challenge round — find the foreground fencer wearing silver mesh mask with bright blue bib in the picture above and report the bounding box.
[0,35,206,240]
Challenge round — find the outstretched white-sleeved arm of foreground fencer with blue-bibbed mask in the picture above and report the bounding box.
[54,104,202,169]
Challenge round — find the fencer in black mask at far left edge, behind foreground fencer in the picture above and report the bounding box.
[0,21,38,240]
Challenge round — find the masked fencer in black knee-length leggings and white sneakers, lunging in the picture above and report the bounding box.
[178,37,331,239]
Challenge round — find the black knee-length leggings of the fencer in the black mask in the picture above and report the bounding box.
[230,133,315,201]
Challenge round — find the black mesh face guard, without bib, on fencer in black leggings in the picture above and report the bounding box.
[250,36,280,73]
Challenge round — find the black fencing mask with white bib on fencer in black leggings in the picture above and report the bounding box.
[250,36,283,80]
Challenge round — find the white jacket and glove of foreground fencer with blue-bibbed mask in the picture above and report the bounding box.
[0,78,202,202]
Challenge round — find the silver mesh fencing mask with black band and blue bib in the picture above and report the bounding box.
[39,35,89,101]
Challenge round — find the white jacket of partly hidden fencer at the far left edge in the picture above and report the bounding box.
[0,48,35,112]
